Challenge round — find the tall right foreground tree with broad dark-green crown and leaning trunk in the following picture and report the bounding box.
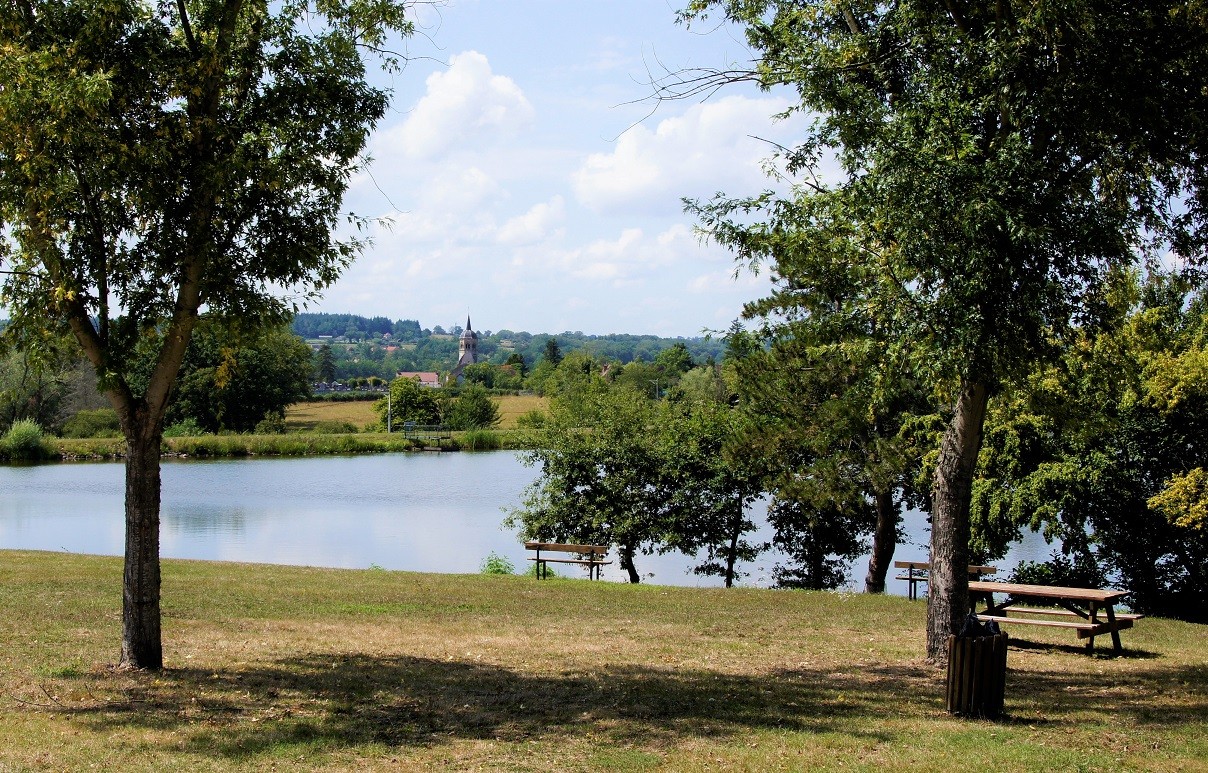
[673,0,1208,662]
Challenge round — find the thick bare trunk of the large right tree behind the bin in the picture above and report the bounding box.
[927,379,989,663]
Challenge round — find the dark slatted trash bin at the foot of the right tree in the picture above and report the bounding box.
[947,615,1006,719]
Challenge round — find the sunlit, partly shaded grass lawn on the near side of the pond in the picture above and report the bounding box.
[0,552,1208,771]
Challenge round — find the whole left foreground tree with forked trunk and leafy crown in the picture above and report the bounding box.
[0,0,410,669]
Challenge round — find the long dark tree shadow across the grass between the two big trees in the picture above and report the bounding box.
[70,656,939,757]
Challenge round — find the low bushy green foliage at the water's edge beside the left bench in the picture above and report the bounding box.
[507,376,761,585]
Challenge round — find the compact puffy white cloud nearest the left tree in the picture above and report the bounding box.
[389,51,533,158]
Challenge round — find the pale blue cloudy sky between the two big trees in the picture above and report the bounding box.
[318,0,803,337]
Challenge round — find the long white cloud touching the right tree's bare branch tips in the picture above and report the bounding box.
[574,97,794,214]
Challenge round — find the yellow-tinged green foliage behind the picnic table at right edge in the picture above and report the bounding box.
[972,273,1208,620]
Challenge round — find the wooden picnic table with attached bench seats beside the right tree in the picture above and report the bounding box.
[969,581,1142,655]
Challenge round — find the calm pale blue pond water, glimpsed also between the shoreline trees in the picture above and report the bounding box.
[0,452,1051,594]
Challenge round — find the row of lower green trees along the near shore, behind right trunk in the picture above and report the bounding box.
[509,271,1208,621]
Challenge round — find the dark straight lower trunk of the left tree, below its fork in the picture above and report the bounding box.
[121,431,163,670]
